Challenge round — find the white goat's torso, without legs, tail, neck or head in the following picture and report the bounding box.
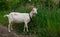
[9,12,30,23]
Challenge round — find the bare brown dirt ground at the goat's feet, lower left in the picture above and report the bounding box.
[0,25,36,37]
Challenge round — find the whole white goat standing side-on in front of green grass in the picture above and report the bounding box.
[4,8,37,32]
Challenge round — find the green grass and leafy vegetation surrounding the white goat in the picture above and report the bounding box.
[0,0,60,37]
